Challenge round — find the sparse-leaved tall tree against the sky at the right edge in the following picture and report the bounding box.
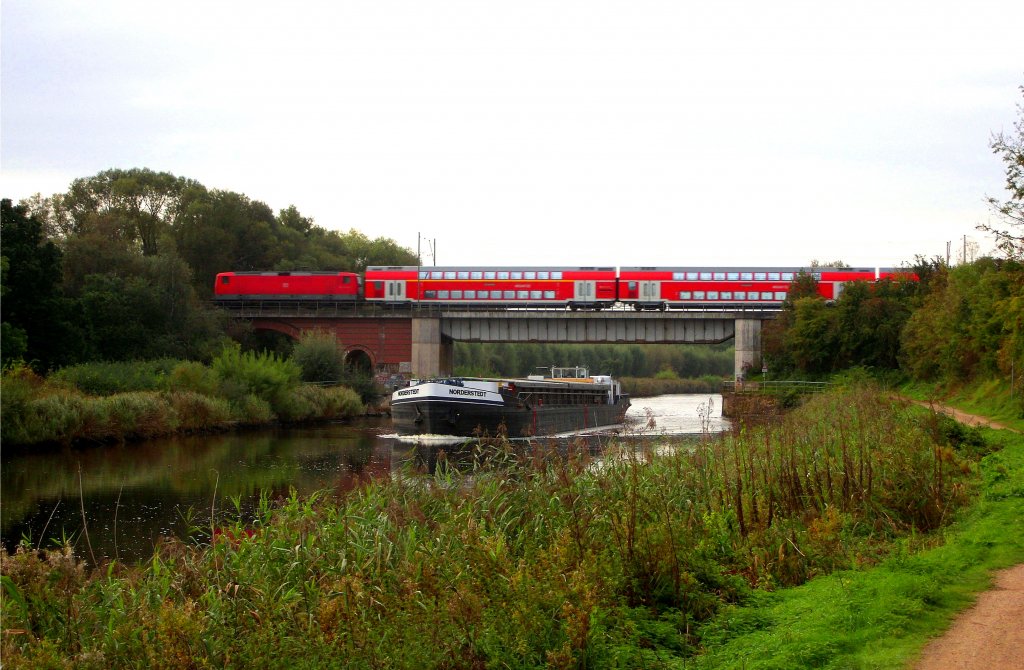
[978,86,1024,260]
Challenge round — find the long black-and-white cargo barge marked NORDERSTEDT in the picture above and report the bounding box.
[391,368,630,437]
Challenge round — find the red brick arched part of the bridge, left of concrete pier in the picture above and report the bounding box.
[251,318,413,371]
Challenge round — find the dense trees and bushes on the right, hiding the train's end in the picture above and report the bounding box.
[764,86,1024,395]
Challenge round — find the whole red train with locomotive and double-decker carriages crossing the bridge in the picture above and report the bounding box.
[214,265,916,309]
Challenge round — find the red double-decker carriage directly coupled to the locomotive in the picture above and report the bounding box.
[364,265,616,309]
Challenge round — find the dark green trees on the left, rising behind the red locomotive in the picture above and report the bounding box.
[0,168,416,371]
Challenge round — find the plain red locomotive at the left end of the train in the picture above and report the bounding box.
[213,271,360,302]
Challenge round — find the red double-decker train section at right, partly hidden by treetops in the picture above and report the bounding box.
[618,267,900,309]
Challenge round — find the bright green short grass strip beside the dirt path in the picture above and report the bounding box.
[689,430,1024,668]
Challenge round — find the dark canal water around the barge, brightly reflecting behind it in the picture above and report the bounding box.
[0,394,728,562]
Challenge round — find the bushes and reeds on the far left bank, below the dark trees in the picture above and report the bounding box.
[0,347,364,446]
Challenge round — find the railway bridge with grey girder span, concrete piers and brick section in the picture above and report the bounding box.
[225,302,775,378]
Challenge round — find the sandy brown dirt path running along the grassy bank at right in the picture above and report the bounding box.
[913,401,1024,670]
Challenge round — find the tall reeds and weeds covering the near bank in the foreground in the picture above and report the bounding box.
[0,389,999,668]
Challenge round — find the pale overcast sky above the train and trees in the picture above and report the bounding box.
[0,0,1024,269]
